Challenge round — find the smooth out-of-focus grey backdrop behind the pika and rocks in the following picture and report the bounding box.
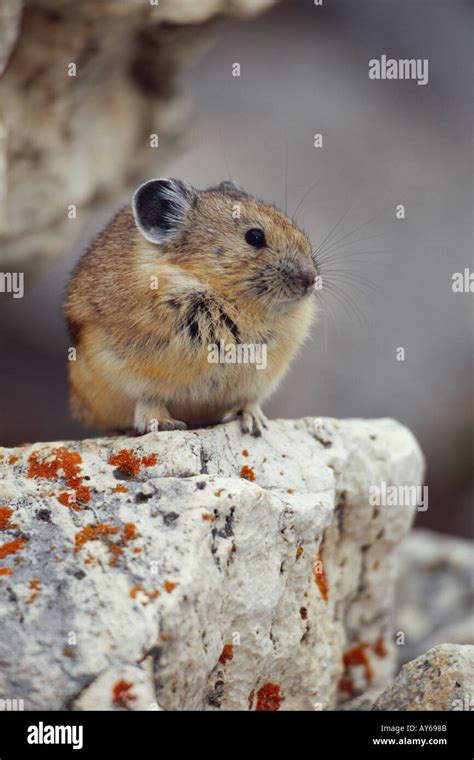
[0,0,474,536]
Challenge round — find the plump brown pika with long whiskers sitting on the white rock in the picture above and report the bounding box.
[64,179,317,435]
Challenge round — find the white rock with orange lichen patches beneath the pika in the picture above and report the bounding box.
[0,418,423,710]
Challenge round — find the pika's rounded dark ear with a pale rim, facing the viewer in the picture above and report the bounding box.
[132,179,196,243]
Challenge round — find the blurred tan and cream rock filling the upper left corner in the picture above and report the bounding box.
[0,0,272,269]
